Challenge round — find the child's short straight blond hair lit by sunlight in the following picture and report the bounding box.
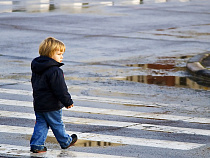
[39,37,66,57]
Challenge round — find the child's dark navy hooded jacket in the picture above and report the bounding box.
[31,56,73,112]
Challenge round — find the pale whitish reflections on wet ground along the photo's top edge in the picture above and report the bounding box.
[0,0,190,13]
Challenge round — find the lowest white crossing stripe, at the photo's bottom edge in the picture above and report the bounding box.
[0,144,131,158]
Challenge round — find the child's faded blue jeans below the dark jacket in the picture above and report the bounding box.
[30,110,72,150]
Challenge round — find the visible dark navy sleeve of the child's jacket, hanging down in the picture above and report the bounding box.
[49,67,73,107]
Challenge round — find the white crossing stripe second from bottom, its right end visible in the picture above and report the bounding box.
[0,125,205,150]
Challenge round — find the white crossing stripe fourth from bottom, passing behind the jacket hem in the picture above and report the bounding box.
[0,99,210,124]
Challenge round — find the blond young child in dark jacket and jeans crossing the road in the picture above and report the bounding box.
[30,37,77,153]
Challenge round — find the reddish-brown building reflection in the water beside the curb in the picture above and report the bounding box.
[122,60,210,90]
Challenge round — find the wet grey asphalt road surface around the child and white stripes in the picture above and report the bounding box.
[0,0,210,158]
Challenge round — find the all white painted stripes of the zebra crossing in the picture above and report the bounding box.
[0,80,210,157]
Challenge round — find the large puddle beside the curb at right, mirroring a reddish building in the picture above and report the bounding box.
[116,56,210,90]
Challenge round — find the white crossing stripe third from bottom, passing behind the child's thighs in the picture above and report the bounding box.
[0,111,210,136]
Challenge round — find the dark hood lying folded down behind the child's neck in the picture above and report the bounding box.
[31,56,64,74]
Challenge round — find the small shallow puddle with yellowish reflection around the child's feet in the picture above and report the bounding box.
[26,135,124,147]
